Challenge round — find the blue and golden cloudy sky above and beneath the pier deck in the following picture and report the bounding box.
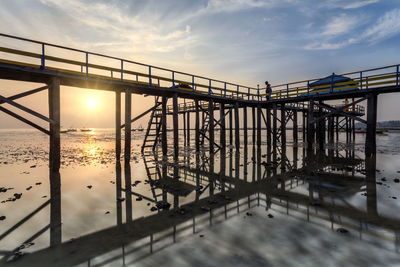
[0,0,400,128]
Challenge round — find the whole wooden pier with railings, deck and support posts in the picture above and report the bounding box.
[0,34,400,258]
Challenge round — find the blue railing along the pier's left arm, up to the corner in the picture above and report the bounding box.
[0,33,259,100]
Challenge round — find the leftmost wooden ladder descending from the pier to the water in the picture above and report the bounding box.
[142,97,162,153]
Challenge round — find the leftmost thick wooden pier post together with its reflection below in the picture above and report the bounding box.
[48,78,61,246]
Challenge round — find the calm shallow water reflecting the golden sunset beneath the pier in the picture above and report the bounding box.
[0,129,400,266]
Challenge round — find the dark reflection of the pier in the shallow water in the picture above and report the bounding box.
[3,147,400,266]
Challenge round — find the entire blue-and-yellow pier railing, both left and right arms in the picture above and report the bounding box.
[0,33,400,101]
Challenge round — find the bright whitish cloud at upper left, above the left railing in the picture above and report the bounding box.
[41,0,196,53]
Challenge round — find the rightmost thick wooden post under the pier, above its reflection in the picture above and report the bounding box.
[365,94,378,157]
